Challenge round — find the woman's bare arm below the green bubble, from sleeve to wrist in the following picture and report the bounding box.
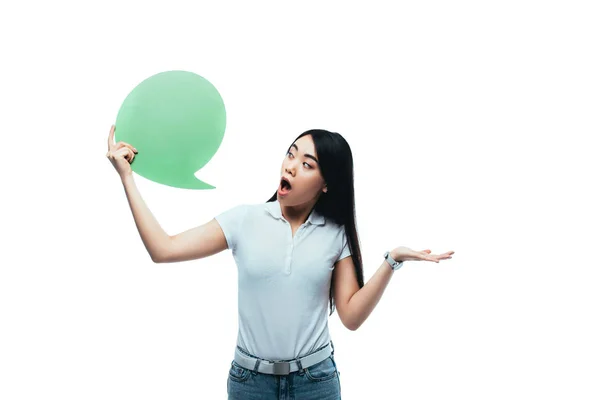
[122,174,227,263]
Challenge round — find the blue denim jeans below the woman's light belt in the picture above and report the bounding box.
[227,346,342,400]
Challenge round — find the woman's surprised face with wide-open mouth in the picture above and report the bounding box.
[277,135,327,206]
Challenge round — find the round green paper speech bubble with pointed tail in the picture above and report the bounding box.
[115,71,226,189]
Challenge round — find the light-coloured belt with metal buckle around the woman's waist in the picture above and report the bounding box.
[234,342,333,375]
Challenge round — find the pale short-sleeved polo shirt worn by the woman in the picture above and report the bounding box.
[215,200,350,360]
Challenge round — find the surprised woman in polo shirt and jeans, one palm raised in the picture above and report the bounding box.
[107,126,454,400]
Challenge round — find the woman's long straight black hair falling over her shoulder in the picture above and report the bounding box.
[267,129,365,315]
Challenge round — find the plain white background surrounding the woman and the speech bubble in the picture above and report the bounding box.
[0,1,600,400]
